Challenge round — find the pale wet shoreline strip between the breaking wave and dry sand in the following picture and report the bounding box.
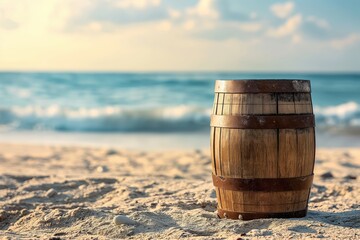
[0,131,360,151]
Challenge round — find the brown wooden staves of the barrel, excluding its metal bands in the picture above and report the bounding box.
[210,79,315,218]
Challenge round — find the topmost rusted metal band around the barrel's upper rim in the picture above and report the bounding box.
[215,79,311,93]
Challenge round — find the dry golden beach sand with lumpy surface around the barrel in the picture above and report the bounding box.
[0,144,360,240]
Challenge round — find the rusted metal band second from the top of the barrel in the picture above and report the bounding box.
[210,114,315,129]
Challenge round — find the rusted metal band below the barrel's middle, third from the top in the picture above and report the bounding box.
[212,174,314,192]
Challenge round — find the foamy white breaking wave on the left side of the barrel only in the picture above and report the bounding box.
[0,105,210,132]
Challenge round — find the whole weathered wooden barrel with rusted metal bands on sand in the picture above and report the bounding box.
[210,79,315,220]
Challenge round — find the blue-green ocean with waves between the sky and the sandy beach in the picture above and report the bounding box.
[0,72,360,147]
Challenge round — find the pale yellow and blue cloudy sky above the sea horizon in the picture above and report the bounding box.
[0,0,360,72]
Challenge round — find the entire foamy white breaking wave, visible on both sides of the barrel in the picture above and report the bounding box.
[0,102,360,132]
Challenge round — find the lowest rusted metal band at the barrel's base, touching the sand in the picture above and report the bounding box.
[217,208,307,220]
